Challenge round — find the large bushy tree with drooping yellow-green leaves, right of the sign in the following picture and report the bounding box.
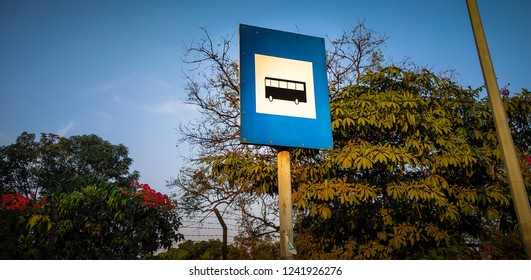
[292,67,530,259]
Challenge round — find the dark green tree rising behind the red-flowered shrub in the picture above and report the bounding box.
[0,132,139,196]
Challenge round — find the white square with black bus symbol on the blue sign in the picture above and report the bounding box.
[254,54,316,119]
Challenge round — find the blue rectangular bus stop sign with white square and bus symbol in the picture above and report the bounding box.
[240,24,333,150]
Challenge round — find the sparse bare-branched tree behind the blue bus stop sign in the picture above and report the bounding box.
[173,21,387,243]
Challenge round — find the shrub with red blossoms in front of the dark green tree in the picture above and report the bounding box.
[0,181,182,259]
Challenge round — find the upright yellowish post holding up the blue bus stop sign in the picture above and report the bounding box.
[278,150,293,260]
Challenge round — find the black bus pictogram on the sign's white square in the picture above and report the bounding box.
[265,77,306,105]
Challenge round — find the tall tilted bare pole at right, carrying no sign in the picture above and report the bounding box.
[466,0,531,259]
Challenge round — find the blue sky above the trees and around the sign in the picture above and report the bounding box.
[0,0,531,195]
